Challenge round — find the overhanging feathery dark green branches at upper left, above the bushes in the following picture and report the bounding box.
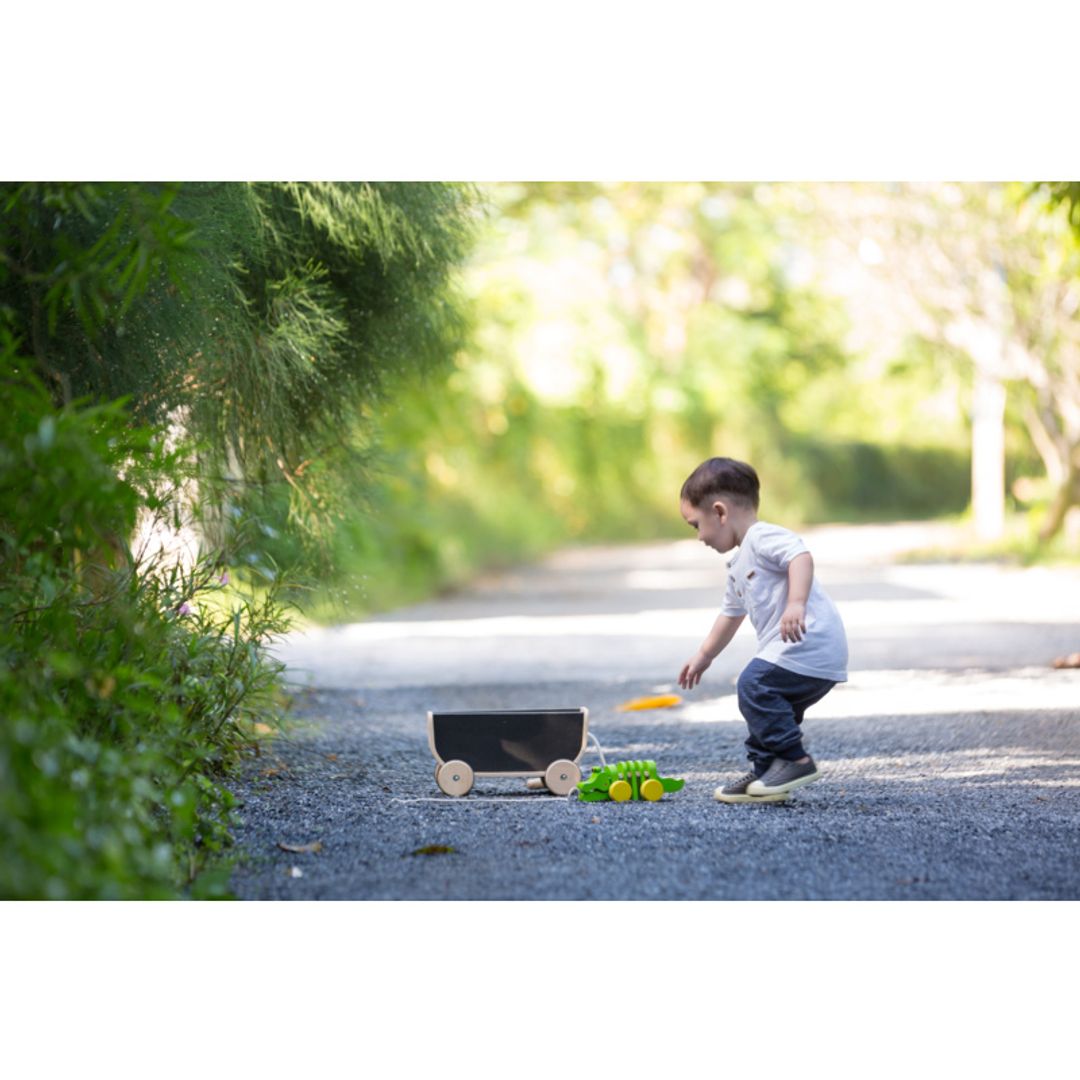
[0,184,476,544]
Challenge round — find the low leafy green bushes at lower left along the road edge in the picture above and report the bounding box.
[0,341,284,899]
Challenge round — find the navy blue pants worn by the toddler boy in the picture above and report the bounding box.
[739,660,836,777]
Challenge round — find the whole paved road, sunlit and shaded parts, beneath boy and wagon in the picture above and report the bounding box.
[227,526,1080,900]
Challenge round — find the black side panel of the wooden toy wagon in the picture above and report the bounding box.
[431,708,586,773]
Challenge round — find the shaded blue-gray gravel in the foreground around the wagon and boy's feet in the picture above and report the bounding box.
[227,673,1080,900]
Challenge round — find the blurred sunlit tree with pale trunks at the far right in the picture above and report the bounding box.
[808,184,1080,540]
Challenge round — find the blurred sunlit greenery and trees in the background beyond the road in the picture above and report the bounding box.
[311,183,1080,612]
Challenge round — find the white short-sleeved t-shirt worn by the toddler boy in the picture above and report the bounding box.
[721,522,848,683]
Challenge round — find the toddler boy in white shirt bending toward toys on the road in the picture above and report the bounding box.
[678,458,848,802]
